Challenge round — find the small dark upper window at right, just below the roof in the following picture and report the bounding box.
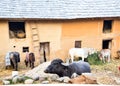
[103,20,112,33]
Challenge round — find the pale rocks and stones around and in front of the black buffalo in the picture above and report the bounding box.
[3,62,111,85]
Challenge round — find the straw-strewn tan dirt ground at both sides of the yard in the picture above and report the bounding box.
[0,59,120,85]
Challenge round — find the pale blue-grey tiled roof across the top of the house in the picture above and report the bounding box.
[0,0,120,19]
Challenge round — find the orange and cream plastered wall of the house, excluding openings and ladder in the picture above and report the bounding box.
[0,19,120,62]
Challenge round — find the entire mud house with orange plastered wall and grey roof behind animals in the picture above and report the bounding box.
[0,0,120,62]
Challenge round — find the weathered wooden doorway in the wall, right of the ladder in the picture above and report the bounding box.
[40,42,50,63]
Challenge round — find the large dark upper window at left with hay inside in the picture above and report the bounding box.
[9,22,26,38]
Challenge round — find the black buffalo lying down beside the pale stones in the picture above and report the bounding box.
[44,59,91,78]
